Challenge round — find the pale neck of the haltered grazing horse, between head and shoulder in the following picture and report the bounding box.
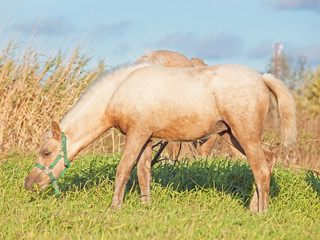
[60,67,137,159]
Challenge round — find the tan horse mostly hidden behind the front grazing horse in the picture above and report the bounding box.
[137,50,242,160]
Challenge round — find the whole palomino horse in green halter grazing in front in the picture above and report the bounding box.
[25,64,297,212]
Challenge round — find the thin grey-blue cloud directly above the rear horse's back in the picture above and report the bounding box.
[153,32,243,59]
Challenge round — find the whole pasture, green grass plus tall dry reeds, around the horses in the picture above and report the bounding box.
[0,45,320,239]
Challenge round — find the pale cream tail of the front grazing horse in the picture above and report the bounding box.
[262,74,297,146]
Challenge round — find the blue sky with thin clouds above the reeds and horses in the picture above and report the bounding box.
[0,0,320,71]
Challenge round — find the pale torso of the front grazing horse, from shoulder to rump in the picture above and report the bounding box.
[108,65,269,140]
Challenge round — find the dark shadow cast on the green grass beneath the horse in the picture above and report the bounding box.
[50,157,279,206]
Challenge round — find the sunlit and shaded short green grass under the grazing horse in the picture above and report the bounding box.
[0,155,320,239]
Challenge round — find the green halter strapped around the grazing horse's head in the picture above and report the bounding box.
[36,133,70,194]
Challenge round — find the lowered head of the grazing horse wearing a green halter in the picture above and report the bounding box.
[25,122,69,190]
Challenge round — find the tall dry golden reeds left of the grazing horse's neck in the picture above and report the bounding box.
[0,44,108,153]
